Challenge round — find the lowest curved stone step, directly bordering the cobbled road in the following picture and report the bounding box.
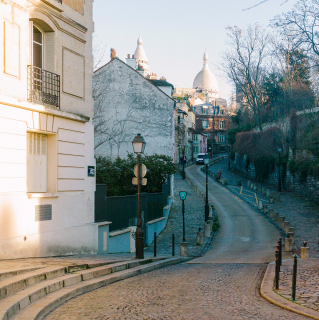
[11,257,185,320]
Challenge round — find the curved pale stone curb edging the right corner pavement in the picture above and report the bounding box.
[260,263,319,320]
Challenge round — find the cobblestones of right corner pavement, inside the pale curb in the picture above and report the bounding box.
[277,259,319,316]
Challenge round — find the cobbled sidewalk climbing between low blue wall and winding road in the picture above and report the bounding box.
[145,174,205,255]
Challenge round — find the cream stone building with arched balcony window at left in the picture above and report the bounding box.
[0,0,97,258]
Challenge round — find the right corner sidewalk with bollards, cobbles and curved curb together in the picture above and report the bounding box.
[260,259,319,319]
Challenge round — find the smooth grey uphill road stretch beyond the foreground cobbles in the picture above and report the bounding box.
[186,166,288,263]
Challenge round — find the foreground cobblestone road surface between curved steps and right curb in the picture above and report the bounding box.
[45,264,308,320]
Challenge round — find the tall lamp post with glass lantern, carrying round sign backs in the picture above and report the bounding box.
[132,133,146,259]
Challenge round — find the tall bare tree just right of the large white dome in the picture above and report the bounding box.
[221,25,269,131]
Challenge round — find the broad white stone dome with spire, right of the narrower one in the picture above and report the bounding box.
[193,50,220,97]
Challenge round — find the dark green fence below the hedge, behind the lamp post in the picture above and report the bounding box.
[95,179,170,231]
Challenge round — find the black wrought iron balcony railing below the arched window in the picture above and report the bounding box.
[28,66,60,108]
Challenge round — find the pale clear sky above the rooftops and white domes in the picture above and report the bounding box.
[93,0,297,100]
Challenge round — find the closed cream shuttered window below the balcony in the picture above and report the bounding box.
[27,132,48,193]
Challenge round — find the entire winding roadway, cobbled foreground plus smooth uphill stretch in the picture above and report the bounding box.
[45,166,308,320]
